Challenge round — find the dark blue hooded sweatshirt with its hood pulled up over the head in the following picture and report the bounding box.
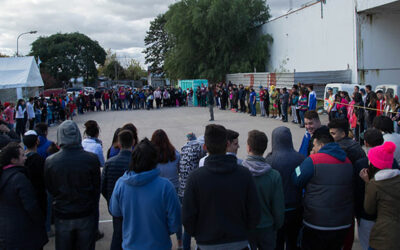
[266,126,305,211]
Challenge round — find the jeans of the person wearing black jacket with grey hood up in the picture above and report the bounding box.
[55,214,97,250]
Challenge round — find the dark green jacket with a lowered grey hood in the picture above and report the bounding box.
[242,155,285,230]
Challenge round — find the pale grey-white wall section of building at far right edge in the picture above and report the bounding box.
[358,1,400,86]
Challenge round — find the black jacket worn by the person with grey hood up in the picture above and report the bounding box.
[45,145,100,219]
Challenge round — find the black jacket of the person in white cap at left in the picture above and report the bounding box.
[25,152,47,216]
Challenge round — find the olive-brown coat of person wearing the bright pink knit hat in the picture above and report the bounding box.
[364,169,400,250]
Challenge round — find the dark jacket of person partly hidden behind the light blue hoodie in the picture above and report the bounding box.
[101,150,132,204]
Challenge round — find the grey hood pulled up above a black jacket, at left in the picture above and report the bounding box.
[57,120,82,147]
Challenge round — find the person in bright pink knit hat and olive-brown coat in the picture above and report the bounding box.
[360,142,400,250]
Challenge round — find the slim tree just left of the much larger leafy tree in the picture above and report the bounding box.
[143,14,171,73]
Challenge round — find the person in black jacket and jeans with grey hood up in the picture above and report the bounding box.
[45,120,100,250]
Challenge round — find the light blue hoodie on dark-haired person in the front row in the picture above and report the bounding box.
[110,168,182,250]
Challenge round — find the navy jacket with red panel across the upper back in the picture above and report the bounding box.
[293,143,354,230]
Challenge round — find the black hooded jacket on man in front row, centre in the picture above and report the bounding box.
[182,155,260,245]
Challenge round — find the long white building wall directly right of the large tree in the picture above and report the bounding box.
[263,0,358,82]
